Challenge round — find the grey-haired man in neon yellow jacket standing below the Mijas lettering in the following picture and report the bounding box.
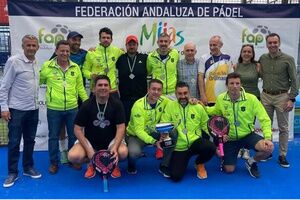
[147,33,179,100]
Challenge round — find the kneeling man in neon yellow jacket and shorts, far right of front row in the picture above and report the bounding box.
[207,73,274,178]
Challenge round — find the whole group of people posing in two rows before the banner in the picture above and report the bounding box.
[0,27,298,187]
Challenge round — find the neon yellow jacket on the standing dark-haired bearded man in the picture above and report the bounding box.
[82,45,124,90]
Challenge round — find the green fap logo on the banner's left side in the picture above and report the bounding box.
[38,24,70,49]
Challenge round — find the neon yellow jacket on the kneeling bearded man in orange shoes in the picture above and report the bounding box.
[161,101,208,151]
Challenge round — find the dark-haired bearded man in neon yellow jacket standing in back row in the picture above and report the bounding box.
[82,27,124,97]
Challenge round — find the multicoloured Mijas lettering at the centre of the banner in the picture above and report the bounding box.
[140,22,184,46]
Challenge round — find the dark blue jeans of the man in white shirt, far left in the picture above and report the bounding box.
[8,109,39,174]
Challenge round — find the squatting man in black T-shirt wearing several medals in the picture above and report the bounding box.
[68,75,128,178]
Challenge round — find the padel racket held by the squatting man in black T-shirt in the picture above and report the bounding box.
[92,150,116,192]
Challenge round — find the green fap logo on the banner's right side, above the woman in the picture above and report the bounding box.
[242,25,271,47]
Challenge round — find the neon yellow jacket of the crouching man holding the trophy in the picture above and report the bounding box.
[126,95,171,144]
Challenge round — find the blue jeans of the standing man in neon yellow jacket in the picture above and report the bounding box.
[47,108,78,165]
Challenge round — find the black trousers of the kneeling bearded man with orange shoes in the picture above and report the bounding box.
[169,138,216,182]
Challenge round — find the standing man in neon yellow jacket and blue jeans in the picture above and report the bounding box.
[40,40,88,174]
